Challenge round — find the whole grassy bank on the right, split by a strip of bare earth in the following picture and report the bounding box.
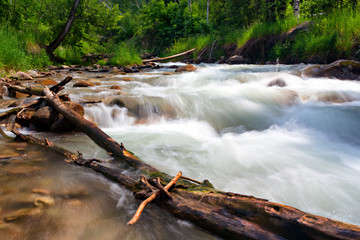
[163,9,360,62]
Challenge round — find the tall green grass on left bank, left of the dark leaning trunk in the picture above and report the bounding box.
[0,26,50,70]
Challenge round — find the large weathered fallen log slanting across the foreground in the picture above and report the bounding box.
[7,88,360,239]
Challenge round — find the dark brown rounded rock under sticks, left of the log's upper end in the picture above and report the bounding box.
[30,106,59,130]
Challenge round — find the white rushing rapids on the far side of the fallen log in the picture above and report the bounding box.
[80,62,360,224]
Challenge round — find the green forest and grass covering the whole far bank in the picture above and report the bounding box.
[0,0,360,73]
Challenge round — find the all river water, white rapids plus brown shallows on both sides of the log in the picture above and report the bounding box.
[0,64,360,239]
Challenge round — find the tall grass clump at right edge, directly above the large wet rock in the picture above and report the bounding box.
[270,9,360,61]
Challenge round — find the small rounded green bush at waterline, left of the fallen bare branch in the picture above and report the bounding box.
[108,42,141,66]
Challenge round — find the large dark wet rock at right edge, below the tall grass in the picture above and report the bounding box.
[303,60,360,81]
